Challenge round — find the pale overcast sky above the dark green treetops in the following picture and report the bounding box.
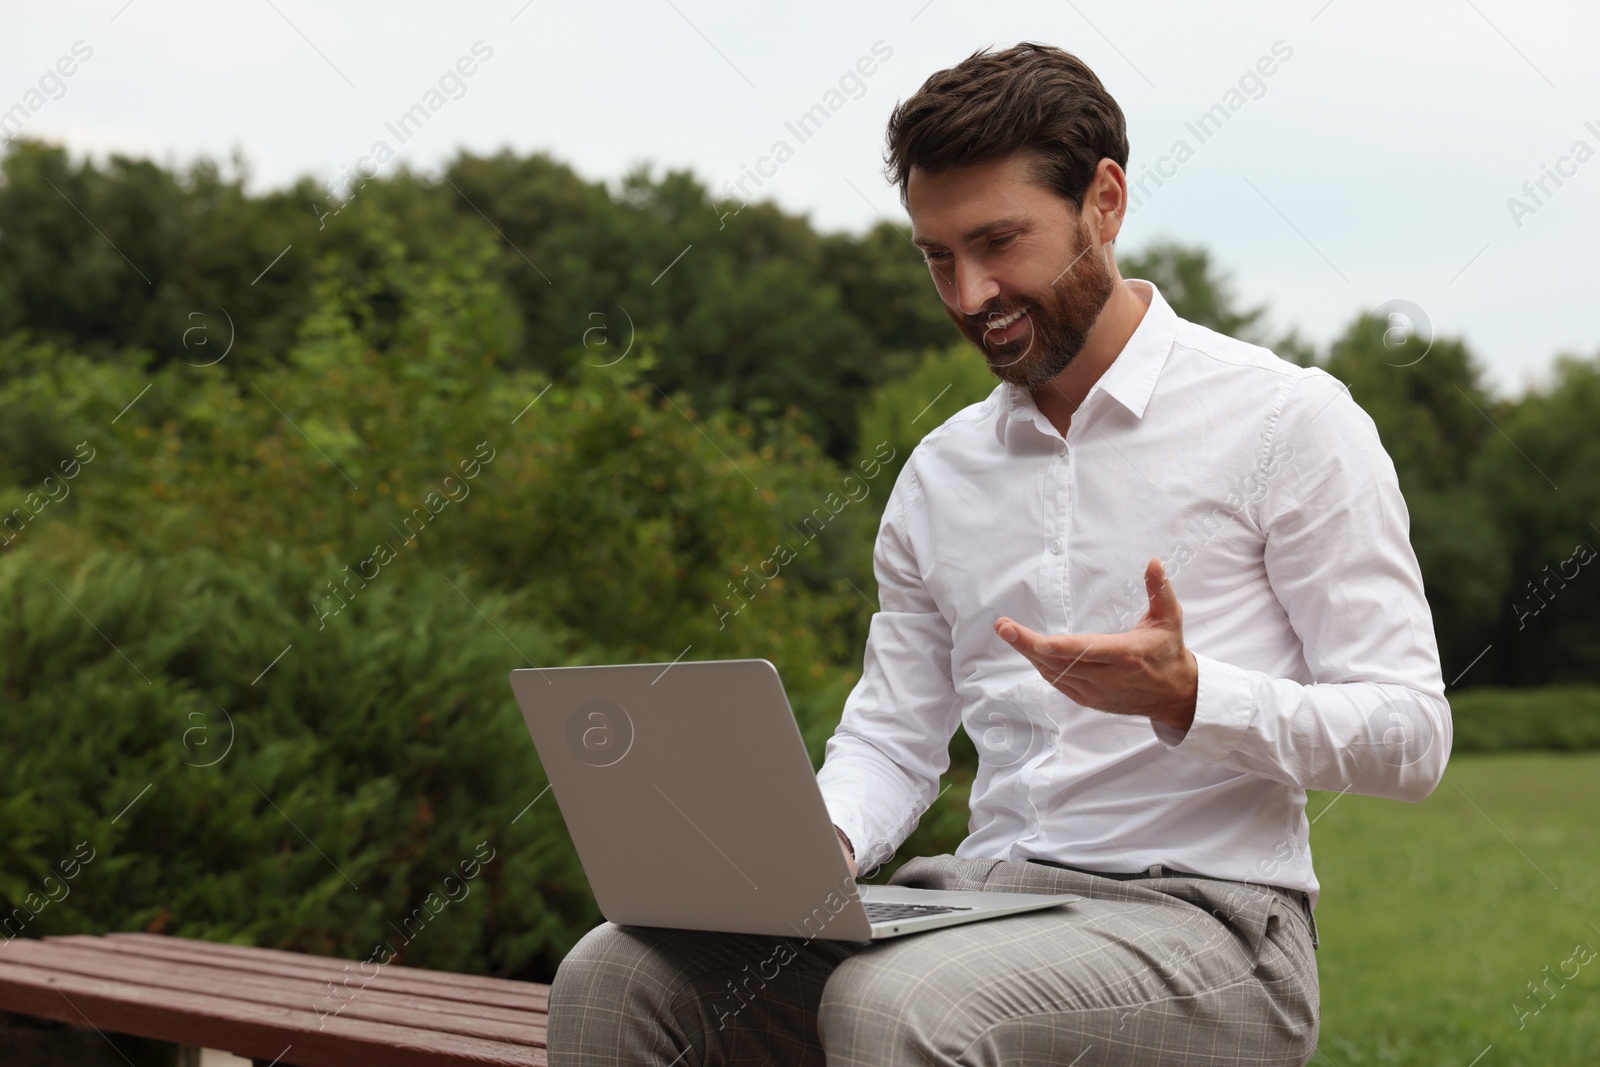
[0,0,1600,392]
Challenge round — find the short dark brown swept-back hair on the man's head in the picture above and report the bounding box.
[883,42,1128,210]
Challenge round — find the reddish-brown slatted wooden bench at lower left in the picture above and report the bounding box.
[0,934,550,1067]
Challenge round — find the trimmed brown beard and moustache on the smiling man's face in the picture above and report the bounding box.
[944,217,1114,389]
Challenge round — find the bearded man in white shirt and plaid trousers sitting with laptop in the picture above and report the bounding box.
[550,43,1450,1067]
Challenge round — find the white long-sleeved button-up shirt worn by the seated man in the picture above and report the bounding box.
[818,282,1451,902]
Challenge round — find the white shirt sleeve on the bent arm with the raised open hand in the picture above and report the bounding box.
[1157,374,1451,801]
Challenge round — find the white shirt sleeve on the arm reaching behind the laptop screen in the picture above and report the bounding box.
[818,454,960,872]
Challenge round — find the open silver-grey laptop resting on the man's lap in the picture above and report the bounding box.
[510,659,1082,941]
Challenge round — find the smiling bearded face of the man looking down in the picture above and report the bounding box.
[906,155,1114,387]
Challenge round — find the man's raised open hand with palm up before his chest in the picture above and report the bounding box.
[995,558,1200,729]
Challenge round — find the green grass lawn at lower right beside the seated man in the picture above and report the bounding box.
[1307,753,1600,1067]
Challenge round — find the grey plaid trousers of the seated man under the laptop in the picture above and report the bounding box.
[549,856,1318,1067]
